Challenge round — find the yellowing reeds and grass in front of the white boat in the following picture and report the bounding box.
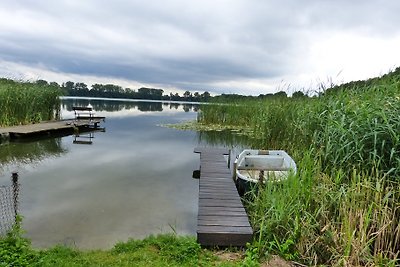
[246,155,400,266]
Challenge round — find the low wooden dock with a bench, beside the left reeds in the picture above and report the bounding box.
[0,119,100,140]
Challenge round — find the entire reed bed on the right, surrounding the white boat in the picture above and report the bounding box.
[199,68,400,266]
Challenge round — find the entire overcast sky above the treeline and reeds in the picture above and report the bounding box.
[0,0,400,95]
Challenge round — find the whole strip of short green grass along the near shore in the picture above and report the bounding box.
[0,219,245,267]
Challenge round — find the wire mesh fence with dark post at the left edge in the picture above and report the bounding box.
[0,173,19,236]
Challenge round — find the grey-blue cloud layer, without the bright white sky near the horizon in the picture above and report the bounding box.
[0,0,400,94]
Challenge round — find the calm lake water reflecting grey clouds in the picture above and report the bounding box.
[0,100,216,248]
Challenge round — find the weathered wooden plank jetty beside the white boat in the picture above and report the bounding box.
[194,148,253,246]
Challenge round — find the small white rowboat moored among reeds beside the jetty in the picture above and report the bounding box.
[234,149,297,194]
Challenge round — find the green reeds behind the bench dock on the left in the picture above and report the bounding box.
[0,79,61,126]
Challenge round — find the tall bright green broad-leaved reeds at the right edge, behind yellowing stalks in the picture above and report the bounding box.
[313,84,400,178]
